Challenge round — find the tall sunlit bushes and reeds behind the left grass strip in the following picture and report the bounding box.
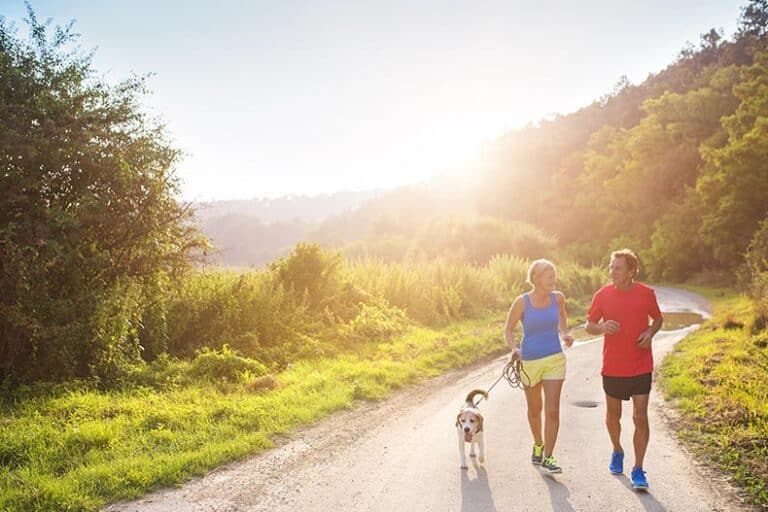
[139,248,605,369]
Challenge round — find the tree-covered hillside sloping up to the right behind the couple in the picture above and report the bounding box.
[478,2,768,280]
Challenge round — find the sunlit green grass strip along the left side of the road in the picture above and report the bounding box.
[0,312,506,511]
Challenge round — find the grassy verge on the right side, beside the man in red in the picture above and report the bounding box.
[660,287,768,508]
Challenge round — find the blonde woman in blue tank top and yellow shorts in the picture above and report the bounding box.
[504,260,573,473]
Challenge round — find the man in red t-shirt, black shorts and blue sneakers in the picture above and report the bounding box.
[586,249,664,490]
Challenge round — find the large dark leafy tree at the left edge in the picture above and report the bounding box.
[0,6,203,381]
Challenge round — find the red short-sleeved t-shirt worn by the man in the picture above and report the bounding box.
[587,283,661,377]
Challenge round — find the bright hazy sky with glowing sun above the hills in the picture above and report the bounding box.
[0,0,744,200]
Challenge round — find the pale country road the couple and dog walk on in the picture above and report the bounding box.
[105,288,749,512]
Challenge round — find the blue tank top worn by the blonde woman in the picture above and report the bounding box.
[520,292,563,361]
